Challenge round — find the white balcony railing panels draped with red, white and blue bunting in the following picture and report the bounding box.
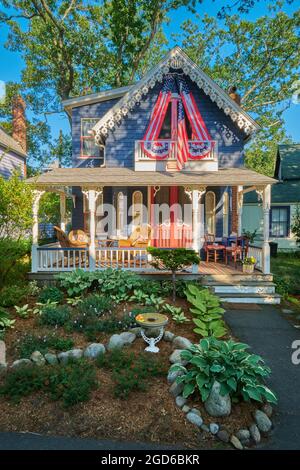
[135,139,217,162]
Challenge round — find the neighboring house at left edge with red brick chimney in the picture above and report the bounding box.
[0,96,27,178]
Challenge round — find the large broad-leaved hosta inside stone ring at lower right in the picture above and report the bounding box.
[171,337,277,403]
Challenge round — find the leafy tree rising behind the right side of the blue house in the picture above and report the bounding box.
[176,5,300,175]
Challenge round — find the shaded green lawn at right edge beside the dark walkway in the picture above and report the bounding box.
[271,252,300,295]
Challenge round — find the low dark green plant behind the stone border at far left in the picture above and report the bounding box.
[15,334,74,358]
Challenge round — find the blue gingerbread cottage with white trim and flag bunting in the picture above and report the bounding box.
[28,47,276,304]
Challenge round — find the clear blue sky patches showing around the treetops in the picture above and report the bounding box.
[0,0,300,142]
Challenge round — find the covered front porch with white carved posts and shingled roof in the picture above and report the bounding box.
[28,168,274,276]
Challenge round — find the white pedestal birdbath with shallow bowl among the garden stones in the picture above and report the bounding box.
[135,313,169,353]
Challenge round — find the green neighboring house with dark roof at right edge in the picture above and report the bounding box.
[243,144,300,251]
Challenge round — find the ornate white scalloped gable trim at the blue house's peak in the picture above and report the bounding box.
[93,46,260,143]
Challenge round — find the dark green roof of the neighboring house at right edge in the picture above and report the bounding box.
[275,144,300,180]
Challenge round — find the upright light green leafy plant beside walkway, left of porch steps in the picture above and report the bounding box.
[186,284,227,338]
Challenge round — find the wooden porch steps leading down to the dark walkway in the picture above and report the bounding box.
[203,274,280,304]
